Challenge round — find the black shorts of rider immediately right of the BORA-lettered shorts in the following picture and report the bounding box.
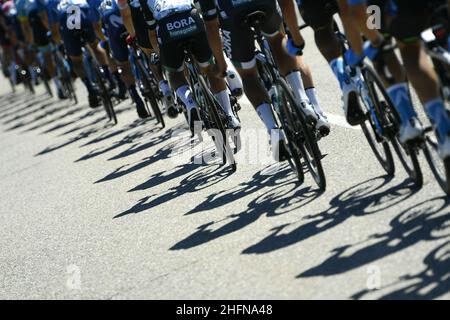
[219,0,283,69]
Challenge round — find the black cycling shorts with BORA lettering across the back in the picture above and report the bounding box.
[156,9,213,71]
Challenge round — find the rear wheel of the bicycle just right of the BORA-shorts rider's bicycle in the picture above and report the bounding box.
[277,78,327,191]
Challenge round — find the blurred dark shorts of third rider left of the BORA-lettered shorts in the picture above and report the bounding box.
[60,8,97,57]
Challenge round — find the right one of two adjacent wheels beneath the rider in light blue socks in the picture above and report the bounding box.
[364,66,423,187]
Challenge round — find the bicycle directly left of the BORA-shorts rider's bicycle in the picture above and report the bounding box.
[130,43,166,129]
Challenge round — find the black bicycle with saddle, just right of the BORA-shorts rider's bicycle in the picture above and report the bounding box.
[250,11,327,191]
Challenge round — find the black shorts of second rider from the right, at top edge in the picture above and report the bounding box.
[297,0,339,31]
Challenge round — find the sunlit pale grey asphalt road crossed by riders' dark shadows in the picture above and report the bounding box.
[0,31,450,299]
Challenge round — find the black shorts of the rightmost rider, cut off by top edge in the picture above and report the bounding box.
[389,0,446,43]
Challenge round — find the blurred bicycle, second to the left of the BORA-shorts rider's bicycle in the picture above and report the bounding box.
[82,39,118,124]
